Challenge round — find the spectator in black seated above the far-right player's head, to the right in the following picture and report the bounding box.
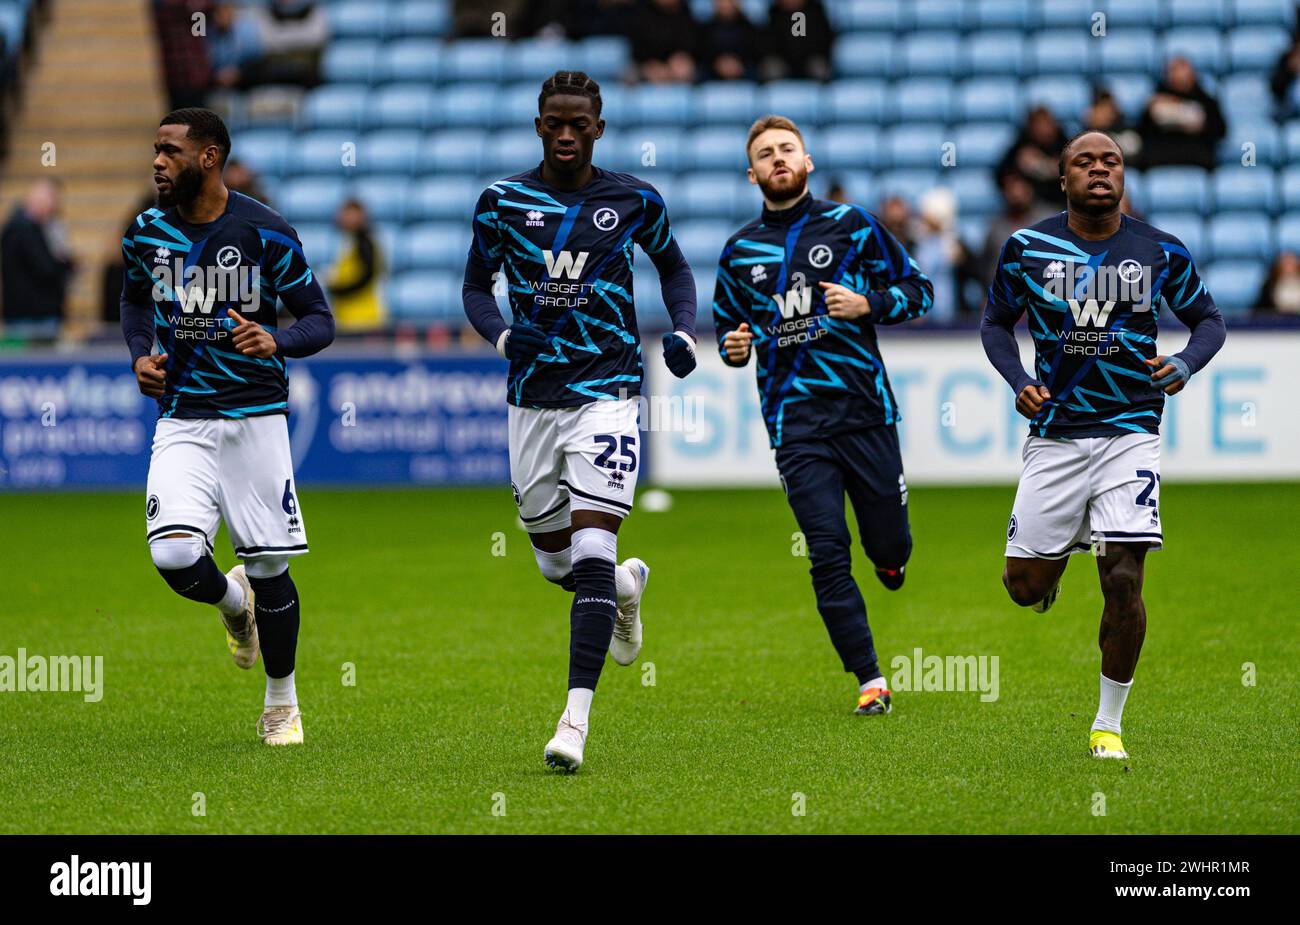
[1138,57,1227,170]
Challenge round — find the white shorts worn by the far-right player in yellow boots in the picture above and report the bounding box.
[1006,434,1164,559]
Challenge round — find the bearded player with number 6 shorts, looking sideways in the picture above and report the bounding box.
[122,109,334,746]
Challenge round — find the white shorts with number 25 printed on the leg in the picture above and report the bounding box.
[508,399,641,533]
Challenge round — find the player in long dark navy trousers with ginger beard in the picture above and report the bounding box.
[714,116,932,716]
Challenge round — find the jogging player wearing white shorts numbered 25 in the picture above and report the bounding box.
[464,70,696,772]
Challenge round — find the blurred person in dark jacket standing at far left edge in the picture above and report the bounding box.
[0,177,77,340]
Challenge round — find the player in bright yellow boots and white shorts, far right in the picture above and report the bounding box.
[980,131,1226,759]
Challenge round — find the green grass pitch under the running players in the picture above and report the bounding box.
[0,479,1300,833]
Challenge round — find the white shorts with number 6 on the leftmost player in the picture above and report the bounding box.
[144,414,307,559]
